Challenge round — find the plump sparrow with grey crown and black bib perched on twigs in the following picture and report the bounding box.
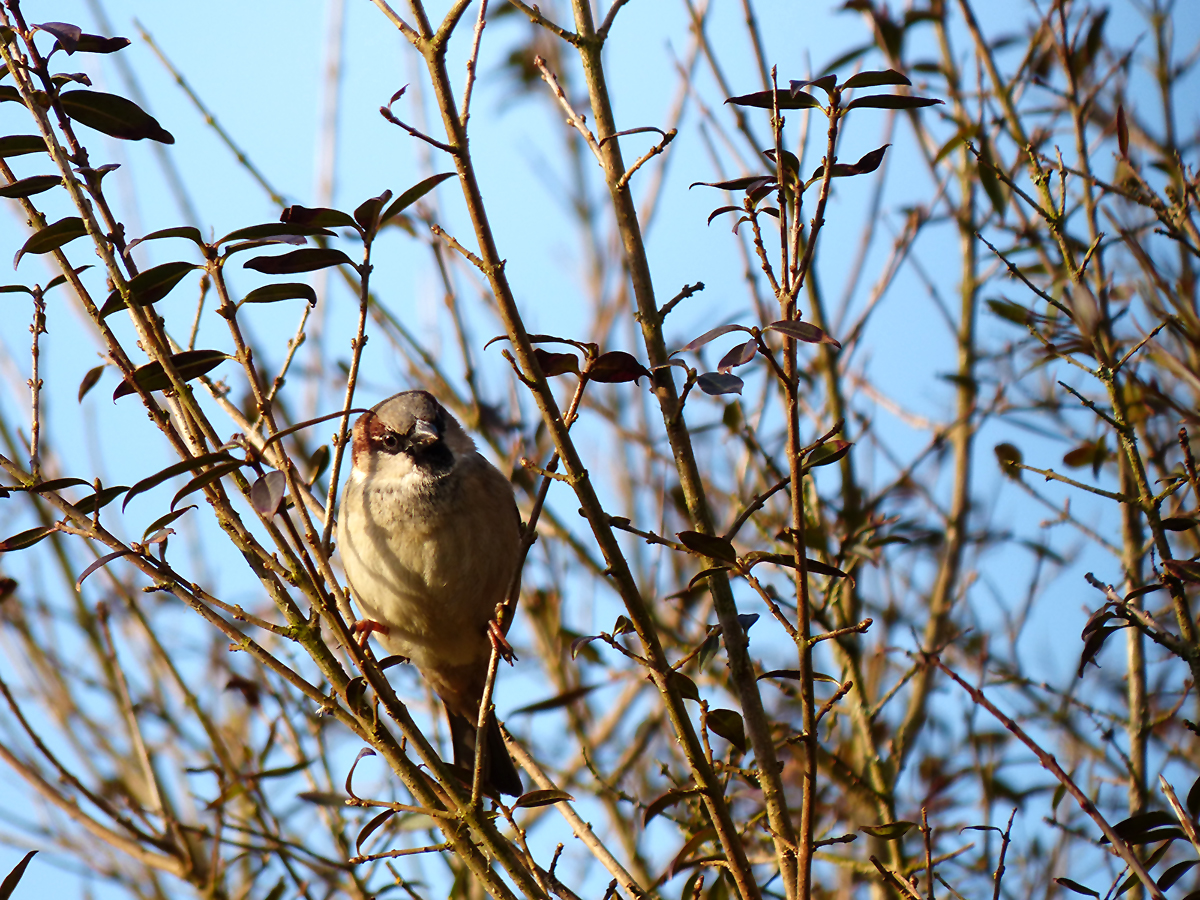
[337,391,521,796]
